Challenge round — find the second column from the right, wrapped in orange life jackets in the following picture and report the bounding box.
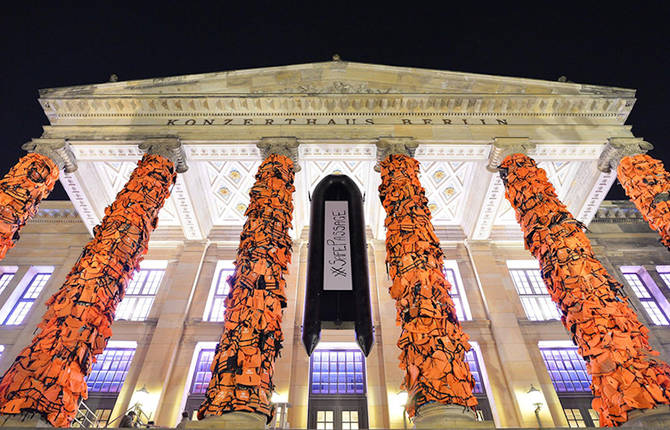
[500,154,670,426]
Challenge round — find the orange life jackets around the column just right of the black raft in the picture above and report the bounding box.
[379,154,477,416]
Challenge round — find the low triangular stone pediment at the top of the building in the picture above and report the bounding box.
[41,61,635,98]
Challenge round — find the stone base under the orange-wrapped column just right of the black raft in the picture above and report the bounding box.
[413,403,495,429]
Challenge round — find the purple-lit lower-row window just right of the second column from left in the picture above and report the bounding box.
[86,348,135,393]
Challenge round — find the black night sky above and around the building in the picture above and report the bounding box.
[0,0,670,199]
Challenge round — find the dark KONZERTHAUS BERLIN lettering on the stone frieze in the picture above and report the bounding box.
[165,117,509,126]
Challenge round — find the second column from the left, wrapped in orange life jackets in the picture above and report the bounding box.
[0,142,176,427]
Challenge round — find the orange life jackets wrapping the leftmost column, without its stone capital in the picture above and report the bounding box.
[0,153,59,260]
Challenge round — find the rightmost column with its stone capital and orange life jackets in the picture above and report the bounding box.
[598,138,670,249]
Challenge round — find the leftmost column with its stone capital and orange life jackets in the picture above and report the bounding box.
[0,139,77,260]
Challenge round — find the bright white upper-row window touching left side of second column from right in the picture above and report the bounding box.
[507,261,561,321]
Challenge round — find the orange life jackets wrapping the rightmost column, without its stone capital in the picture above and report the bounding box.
[617,154,670,249]
